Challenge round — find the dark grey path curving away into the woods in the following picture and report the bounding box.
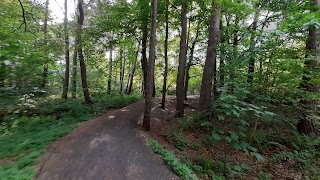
[36,102,179,180]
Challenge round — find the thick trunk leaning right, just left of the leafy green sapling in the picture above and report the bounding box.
[198,1,221,111]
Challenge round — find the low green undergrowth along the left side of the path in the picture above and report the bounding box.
[0,95,141,180]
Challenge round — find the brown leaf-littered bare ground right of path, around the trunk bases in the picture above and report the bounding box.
[146,96,308,180]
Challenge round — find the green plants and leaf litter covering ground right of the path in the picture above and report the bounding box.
[146,88,320,180]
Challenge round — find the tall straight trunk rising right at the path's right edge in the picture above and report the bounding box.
[143,0,157,131]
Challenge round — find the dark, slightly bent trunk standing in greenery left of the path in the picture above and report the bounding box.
[78,0,91,104]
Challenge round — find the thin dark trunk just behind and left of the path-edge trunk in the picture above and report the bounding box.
[141,22,148,96]
